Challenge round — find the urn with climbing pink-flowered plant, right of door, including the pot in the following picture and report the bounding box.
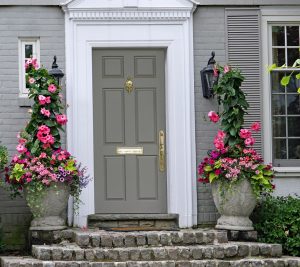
[198,66,274,230]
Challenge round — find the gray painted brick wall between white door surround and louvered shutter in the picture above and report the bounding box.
[194,6,226,224]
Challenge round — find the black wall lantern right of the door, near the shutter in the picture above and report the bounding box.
[200,51,218,98]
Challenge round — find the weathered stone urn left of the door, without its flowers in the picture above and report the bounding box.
[25,183,69,230]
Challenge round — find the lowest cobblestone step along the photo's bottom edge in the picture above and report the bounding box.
[1,257,300,267]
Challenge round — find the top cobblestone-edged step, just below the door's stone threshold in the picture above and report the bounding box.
[31,229,228,248]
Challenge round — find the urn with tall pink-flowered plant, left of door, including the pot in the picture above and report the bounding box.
[5,59,90,230]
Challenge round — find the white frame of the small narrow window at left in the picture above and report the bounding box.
[19,37,40,98]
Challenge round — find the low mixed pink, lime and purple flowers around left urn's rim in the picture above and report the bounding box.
[5,149,90,200]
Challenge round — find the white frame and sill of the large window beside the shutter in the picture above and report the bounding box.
[261,6,300,176]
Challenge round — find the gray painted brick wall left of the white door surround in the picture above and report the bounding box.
[0,6,65,248]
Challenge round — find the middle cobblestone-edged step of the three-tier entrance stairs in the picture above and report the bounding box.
[32,242,282,262]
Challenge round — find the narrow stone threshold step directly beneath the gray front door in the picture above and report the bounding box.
[88,214,178,230]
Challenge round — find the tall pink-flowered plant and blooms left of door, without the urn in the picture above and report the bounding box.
[5,59,90,214]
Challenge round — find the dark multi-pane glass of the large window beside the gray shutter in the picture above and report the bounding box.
[270,24,300,167]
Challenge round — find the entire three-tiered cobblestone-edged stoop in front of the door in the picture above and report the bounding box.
[1,229,300,267]
